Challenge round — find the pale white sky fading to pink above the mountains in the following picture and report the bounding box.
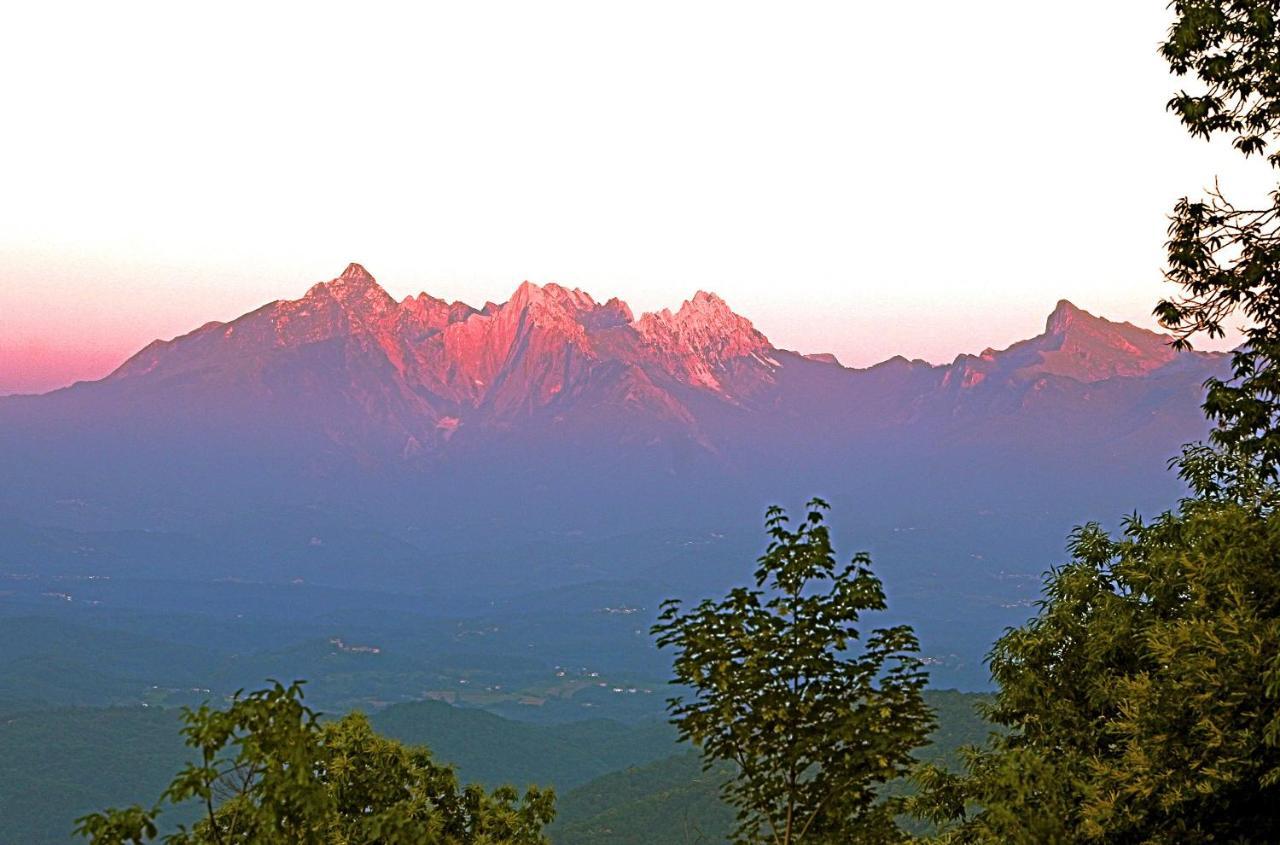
[0,0,1274,393]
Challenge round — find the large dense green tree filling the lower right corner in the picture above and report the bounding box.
[915,478,1280,844]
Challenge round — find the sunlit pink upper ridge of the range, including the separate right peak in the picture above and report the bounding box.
[94,264,1213,466]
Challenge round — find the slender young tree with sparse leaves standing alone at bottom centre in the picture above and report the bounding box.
[653,499,933,845]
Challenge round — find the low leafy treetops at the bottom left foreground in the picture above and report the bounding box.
[77,682,554,845]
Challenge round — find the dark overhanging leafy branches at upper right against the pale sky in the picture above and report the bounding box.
[1156,0,1280,479]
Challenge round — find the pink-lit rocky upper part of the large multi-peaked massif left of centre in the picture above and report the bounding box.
[102,264,777,452]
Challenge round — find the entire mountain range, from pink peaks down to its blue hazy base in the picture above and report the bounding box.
[0,264,1226,686]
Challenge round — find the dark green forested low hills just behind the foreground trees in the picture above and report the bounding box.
[0,691,986,845]
